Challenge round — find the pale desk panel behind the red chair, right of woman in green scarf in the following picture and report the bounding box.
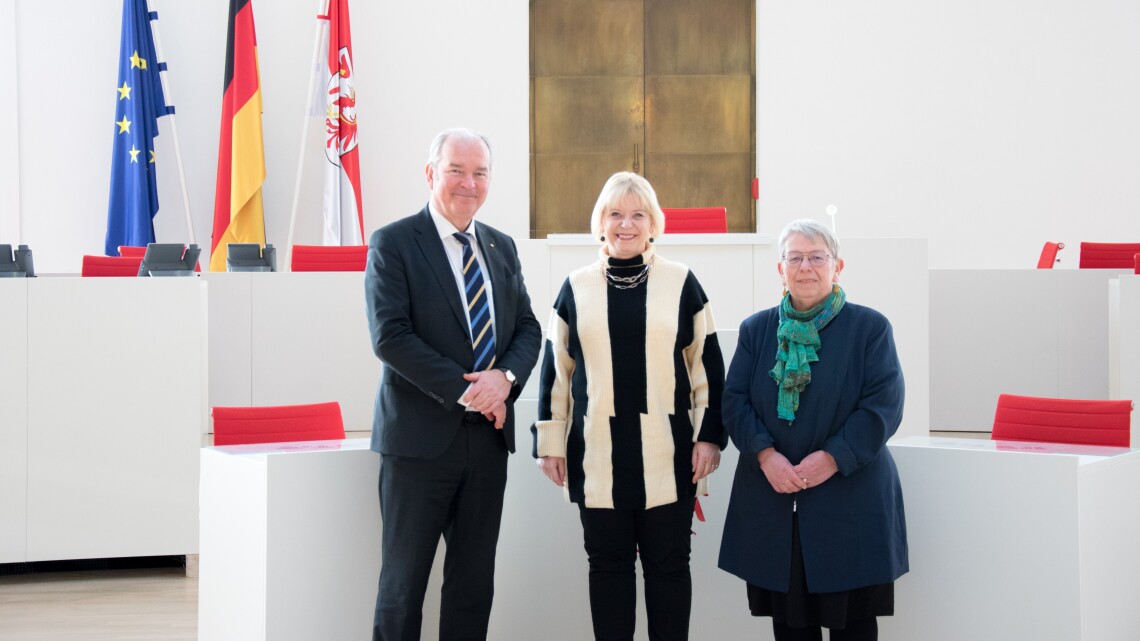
[929,269,1121,431]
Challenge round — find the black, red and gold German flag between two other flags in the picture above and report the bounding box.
[210,0,266,271]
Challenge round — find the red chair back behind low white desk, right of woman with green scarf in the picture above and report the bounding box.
[991,393,1132,447]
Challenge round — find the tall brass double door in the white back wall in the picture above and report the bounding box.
[530,0,756,238]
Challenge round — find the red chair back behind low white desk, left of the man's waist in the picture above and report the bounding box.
[211,400,344,445]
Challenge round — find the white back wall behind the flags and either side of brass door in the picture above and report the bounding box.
[8,0,1140,271]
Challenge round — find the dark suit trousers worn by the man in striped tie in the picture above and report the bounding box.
[372,416,507,641]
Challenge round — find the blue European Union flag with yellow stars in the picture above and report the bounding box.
[105,0,174,255]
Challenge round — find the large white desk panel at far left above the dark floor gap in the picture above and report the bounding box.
[27,278,206,561]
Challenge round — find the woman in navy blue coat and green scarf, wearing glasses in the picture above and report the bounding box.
[719,220,907,641]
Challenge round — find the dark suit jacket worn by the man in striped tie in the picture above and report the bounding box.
[364,206,542,459]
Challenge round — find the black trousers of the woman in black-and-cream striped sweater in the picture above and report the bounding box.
[580,498,693,641]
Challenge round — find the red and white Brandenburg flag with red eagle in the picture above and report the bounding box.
[314,0,364,245]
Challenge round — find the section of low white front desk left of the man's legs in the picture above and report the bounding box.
[198,439,381,641]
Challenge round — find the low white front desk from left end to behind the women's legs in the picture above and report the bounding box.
[198,431,766,641]
